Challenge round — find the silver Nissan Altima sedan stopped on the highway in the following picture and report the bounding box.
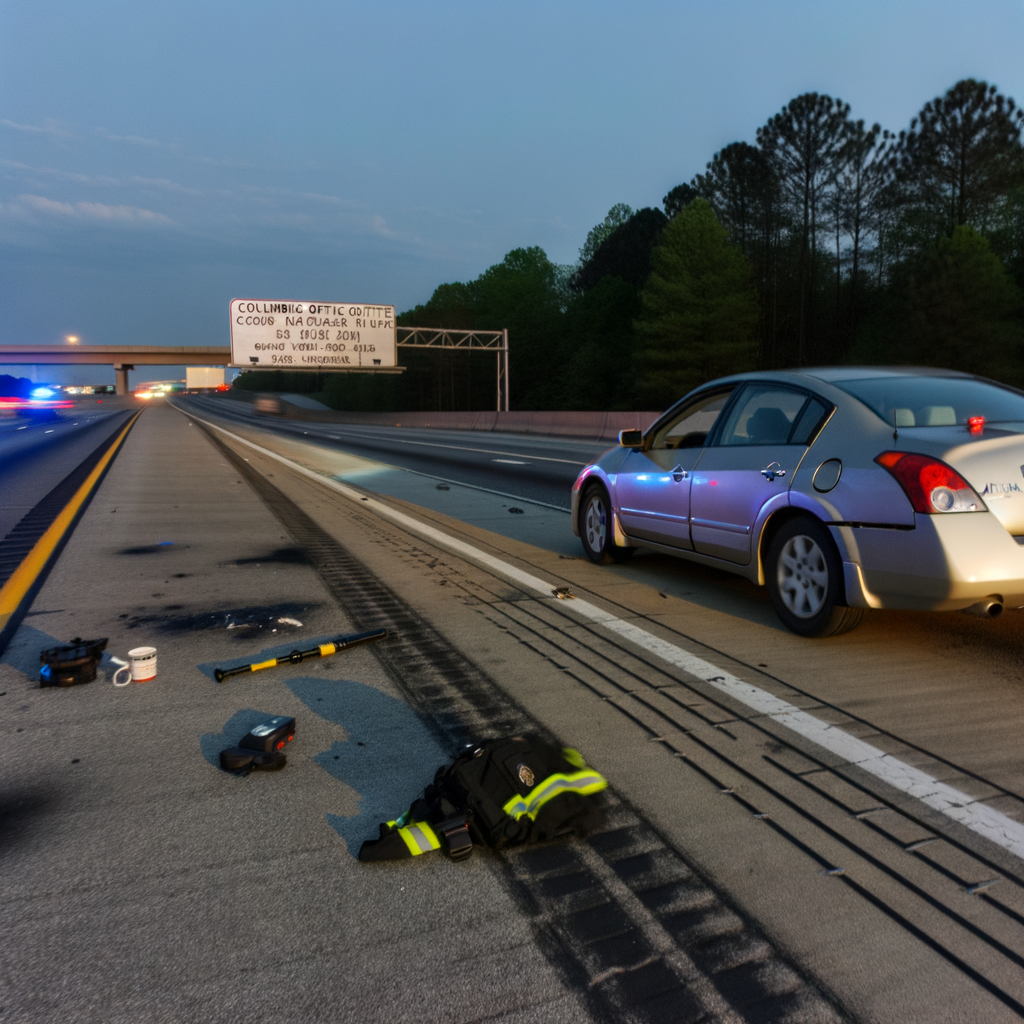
[572,367,1024,637]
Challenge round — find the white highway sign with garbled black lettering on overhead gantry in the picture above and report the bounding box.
[231,299,398,370]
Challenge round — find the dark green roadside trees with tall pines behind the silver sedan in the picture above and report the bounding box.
[237,79,1024,410]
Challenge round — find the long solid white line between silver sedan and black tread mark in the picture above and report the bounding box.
[192,407,1024,858]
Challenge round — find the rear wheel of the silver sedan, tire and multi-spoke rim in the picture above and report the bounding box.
[765,515,864,637]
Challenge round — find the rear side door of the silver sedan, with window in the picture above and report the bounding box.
[690,382,825,565]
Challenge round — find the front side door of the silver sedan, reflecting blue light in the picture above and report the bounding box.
[614,388,732,549]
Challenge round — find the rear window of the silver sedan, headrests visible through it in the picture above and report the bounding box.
[834,377,1024,427]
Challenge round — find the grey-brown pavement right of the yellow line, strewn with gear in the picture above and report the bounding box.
[6,401,1024,1024]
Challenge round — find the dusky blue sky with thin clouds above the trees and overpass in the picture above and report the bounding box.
[0,0,1024,380]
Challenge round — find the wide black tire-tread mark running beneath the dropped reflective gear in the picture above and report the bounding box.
[203,428,850,1024]
